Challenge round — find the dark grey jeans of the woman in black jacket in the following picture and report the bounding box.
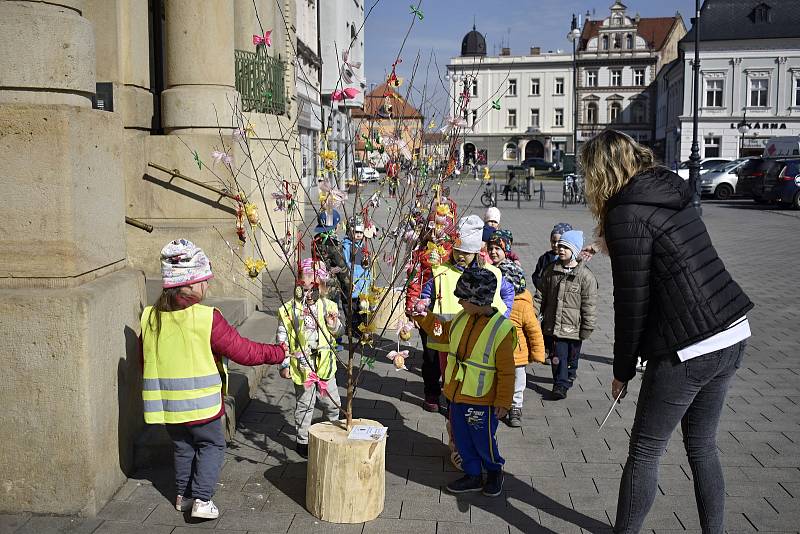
[614,341,746,534]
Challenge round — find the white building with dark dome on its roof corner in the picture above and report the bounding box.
[447,28,574,165]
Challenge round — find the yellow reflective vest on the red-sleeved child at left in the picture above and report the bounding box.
[141,304,228,424]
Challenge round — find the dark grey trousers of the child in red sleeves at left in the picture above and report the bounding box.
[164,417,225,501]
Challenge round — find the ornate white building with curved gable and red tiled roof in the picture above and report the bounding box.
[577,0,686,145]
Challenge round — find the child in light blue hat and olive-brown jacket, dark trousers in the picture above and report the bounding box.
[535,230,597,400]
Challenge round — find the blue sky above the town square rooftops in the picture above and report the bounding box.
[362,0,694,116]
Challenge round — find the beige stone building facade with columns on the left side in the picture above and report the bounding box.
[0,0,299,515]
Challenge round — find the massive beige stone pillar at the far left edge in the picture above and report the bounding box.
[0,0,143,515]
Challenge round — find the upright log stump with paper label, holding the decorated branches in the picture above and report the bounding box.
[306,419,386,523]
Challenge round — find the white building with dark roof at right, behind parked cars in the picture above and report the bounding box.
[656,0,800,166]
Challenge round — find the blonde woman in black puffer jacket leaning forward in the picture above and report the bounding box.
[580,130,753,533]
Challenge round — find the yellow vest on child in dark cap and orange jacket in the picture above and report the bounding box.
[444,312,517,397]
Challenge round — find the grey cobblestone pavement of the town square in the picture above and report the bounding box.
[6,182,800,534]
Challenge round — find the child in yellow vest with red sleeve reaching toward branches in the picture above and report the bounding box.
[141,239,287,519]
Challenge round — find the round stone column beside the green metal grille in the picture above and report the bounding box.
[161,0,238,134]
